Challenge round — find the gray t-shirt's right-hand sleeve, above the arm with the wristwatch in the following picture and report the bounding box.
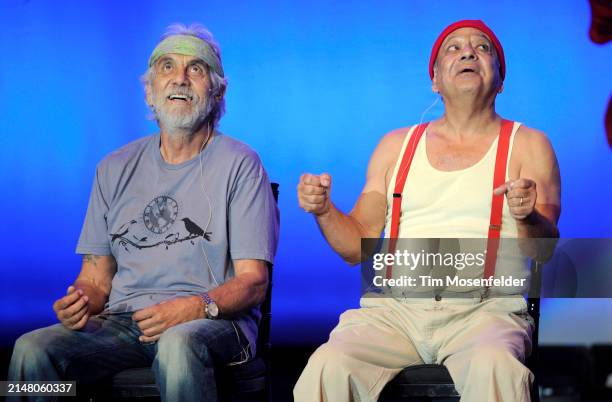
[228,158,279,263]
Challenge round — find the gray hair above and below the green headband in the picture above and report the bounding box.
[141,23,227,127]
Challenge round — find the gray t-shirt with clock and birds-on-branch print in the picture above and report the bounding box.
[76,133,279,351]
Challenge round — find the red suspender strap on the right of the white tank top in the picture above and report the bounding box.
[483,120,514,279]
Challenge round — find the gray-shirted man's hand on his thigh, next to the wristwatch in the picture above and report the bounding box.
[132,296,204,343]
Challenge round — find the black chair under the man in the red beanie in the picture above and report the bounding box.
[378,261,542,402]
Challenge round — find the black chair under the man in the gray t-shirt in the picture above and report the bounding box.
[89,183,279,402]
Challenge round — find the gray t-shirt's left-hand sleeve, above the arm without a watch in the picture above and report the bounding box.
[76,166,111,255]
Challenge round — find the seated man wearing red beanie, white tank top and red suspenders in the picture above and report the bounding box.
[294,20,561,402]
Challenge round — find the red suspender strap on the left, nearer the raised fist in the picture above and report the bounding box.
[386,123,429,279]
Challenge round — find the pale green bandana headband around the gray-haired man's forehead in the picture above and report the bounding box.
[149,35,224,77]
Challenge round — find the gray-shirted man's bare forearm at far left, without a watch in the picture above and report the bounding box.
[74,254,117,315]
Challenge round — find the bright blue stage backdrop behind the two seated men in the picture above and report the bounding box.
[0,0,612,344]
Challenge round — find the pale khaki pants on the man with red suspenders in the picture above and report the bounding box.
[293,297,533,402]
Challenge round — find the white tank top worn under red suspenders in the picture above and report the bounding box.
[385,122,530,296]
